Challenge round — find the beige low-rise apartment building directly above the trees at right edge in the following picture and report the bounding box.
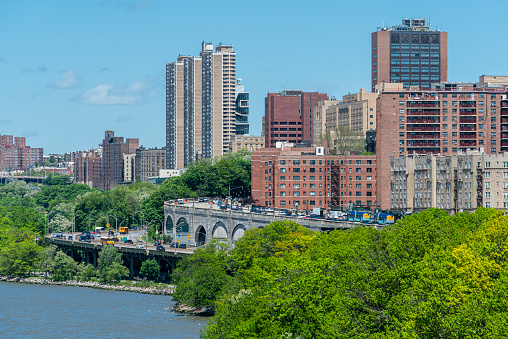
[390,151,508,213]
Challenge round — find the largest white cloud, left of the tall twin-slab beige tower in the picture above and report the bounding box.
[73,77,157,105]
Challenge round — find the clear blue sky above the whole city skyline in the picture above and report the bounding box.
[0,0,508,154]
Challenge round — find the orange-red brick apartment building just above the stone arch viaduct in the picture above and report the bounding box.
[251,147,377,210]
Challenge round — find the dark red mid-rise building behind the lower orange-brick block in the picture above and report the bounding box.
[263,89,328,148]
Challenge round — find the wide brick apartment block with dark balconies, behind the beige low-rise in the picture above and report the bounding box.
[376,80,508,209]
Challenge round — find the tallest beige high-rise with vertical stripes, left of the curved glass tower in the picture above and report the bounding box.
[166,42,236,169]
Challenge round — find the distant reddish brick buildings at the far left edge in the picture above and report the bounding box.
[0,135,44,171]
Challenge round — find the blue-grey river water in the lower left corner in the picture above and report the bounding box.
[0,282,208,338]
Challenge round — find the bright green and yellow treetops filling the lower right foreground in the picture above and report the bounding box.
[191,208,508,338]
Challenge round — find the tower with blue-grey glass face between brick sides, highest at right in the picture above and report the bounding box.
[371,19,448,92]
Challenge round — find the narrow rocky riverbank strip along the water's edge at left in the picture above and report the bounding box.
[0,276,175,296]
